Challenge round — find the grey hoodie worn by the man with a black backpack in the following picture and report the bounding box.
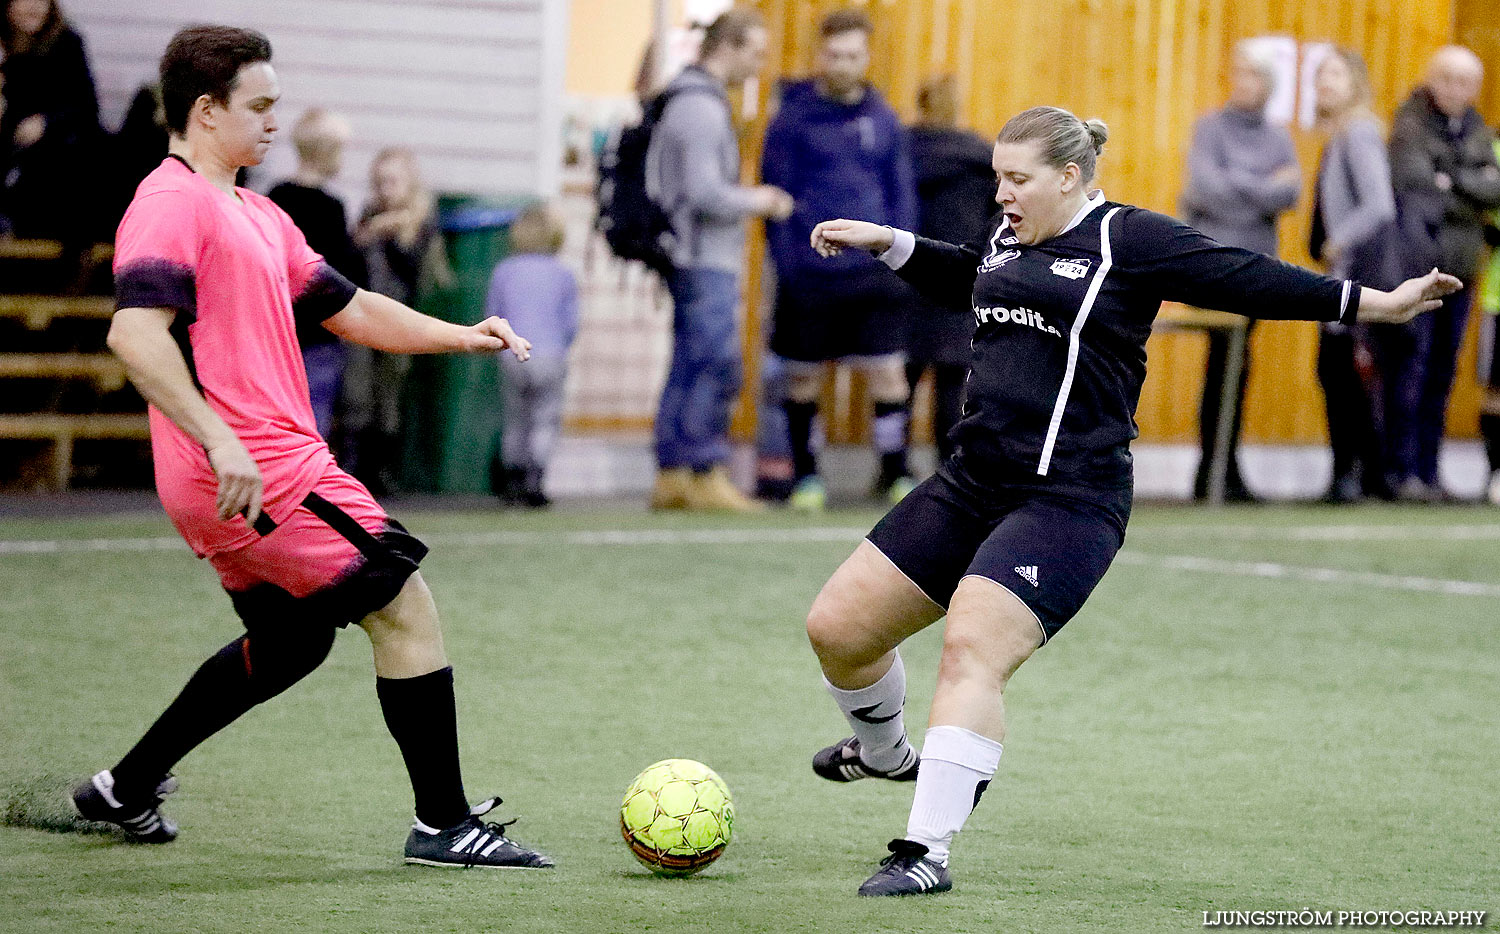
[647,64,755,274]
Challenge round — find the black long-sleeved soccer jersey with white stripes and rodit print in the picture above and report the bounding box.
[897,192,1359,489]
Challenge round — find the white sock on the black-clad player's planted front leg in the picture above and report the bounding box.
[906,727,1001,865]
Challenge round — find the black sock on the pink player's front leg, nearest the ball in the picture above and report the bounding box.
[375,666,468,829]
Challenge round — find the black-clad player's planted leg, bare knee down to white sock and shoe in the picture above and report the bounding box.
[860,576,1043,895]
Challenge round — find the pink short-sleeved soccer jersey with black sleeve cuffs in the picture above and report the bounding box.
[114,157,354,556]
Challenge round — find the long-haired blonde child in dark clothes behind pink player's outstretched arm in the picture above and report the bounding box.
[341,147,450,495]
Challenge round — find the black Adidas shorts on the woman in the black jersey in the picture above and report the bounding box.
[867,463,1125,642]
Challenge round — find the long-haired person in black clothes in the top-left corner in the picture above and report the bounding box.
[0,0,102,240]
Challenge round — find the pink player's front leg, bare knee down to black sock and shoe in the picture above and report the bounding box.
[360,573,552,870]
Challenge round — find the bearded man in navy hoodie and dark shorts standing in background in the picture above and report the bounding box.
[762,9,917,511]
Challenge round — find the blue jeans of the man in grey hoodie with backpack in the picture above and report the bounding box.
[656,268,743,471]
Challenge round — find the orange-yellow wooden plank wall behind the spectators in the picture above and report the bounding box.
[741,0,1482,442]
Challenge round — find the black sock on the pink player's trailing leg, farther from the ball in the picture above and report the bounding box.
[111,627,335,802]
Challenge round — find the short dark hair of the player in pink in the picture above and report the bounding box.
[162,25,272,135]
